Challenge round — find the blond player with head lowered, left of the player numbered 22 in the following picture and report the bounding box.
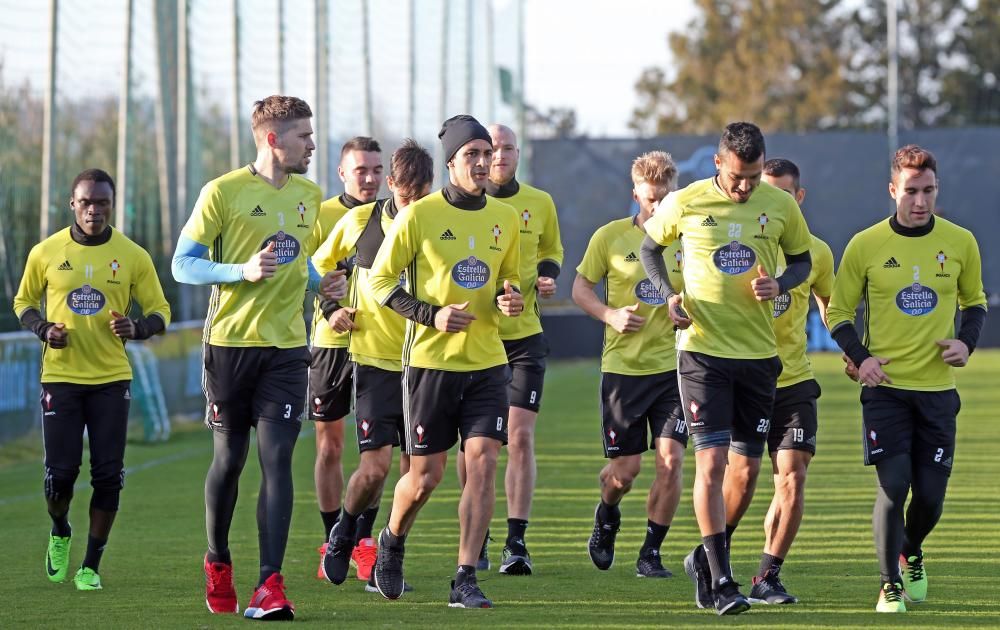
[573,151,688,578]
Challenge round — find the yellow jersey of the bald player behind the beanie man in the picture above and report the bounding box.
[498,182,563,341]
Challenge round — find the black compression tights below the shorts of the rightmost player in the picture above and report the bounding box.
[872,454,948,582]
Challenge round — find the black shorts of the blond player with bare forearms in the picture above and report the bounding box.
[601,370,688,458]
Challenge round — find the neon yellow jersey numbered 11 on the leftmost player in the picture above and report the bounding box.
[14,228,170,385]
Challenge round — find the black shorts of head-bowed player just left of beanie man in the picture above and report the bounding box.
[354,365,406,453]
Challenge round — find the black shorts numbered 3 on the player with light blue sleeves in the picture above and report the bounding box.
[203,344,309,433]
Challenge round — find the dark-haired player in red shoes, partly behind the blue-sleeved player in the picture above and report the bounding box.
[309,136,382,579]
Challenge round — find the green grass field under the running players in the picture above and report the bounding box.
[0,351,1000,628]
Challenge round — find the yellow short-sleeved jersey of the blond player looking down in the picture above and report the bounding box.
[576,217,684,376]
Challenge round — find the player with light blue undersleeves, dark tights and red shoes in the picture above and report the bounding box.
[172,95,346,620]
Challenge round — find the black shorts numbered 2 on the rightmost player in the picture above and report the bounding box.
[861,385,962,475]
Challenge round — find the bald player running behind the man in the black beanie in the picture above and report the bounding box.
[458,124,563,575]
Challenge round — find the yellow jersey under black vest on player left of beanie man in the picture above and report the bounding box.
[313,202,406,372]
